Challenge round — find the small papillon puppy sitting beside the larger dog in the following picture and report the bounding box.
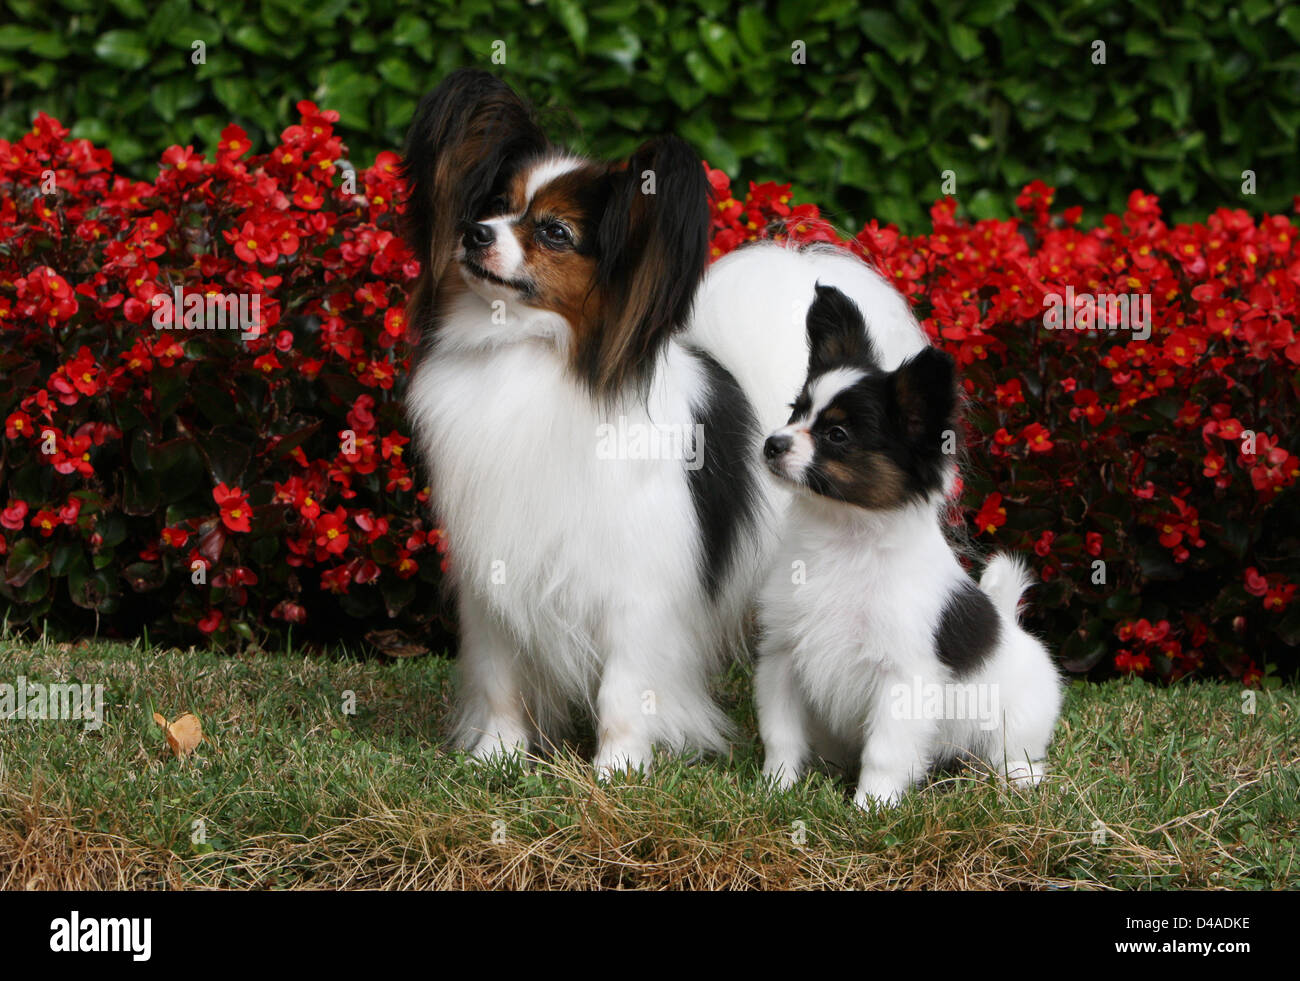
[754,286,1061,807]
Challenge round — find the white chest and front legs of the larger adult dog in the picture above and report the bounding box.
[408,298,753,760]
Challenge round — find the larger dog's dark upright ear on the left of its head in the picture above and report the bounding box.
[403,69,546,288]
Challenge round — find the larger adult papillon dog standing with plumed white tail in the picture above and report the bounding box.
[404,70,924,773]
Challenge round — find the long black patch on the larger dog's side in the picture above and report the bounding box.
[686,348,762,599]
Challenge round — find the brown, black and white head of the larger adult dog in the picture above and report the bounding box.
[416,120,710,399]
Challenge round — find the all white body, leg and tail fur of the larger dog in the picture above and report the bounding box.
[407,244,926,771]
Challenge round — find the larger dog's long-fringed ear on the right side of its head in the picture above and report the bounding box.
[592,136,710,394]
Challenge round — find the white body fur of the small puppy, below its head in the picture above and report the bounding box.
[754,452,1061,807]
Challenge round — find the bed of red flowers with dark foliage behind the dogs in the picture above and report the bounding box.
[0,109,1300,682]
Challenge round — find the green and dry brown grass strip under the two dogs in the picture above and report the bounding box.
[0,639,1300,889]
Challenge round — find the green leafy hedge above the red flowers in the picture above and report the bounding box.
[0,0,1300,230]
